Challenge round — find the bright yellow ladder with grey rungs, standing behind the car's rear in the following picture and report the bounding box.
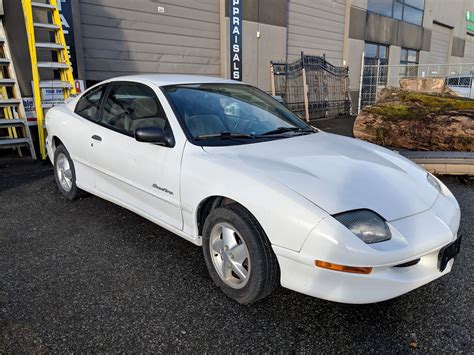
[22,0,76,159]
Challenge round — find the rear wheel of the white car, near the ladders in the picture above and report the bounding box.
[54,145,85,201]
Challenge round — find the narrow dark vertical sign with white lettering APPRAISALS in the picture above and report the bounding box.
[229,0,243,81]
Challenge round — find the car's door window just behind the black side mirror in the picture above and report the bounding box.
[99,83,168,136]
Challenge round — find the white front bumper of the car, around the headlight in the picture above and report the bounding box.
[274,191,460,303]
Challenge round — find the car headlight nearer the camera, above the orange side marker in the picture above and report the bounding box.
[333,210,392,244]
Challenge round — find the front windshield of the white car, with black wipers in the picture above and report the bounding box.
[164,83,314,145]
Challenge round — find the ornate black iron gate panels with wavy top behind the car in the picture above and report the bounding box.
[271,53,351,121]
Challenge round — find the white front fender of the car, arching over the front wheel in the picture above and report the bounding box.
[181,144,328,251]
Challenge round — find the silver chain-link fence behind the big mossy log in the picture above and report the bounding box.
[358,64,474,112]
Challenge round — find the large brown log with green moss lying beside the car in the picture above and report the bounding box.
[354,89,474,152]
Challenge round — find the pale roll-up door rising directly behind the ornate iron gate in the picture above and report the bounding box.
[288,0,345,65]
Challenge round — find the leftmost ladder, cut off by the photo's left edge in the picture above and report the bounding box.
[0,19,36,159]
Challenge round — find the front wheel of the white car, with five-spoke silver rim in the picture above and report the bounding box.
[203,203,280,304]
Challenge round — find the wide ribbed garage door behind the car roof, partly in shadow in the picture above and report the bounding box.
[80,0,221,80]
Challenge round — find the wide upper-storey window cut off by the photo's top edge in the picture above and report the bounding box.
[367,0,425,26]
